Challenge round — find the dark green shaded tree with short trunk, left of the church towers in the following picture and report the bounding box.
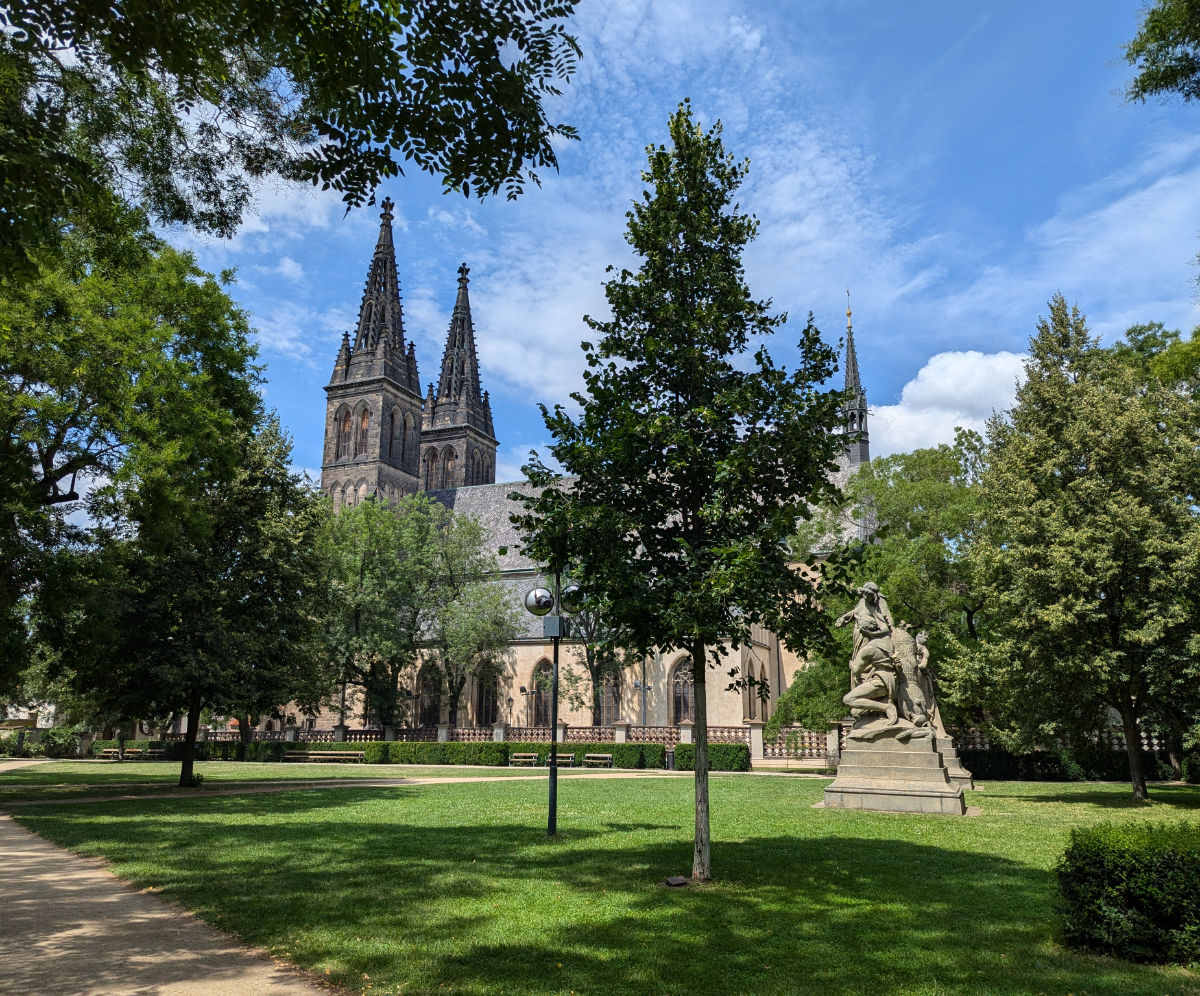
[43,418,331,785]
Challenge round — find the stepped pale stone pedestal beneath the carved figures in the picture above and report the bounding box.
[824,718,967,816]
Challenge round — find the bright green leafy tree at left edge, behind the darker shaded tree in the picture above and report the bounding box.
[0,205,258,690]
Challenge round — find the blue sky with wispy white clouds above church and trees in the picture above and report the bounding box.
[169,0,1200,480]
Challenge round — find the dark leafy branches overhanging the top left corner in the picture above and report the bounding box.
[0,0,580,274]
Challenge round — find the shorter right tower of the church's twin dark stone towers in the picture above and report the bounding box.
[421,263,497,491]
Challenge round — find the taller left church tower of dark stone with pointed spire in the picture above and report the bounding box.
[320,198,421,508]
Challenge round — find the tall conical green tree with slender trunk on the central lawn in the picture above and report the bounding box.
[517,103,842,881]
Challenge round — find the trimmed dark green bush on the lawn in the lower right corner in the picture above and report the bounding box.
[1056,823,1200,965]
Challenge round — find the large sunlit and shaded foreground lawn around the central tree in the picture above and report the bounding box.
[14,775,1200,996]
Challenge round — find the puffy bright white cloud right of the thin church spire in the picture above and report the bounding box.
[868,349,1025,456]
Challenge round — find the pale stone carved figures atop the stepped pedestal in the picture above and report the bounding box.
[834,581,930,740]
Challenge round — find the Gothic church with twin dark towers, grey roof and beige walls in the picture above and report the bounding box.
[316,200,870,740]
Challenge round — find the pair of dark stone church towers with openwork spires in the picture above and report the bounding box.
[320,198,497,506]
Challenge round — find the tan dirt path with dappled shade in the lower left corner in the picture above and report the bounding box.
[0,815,330,996]
